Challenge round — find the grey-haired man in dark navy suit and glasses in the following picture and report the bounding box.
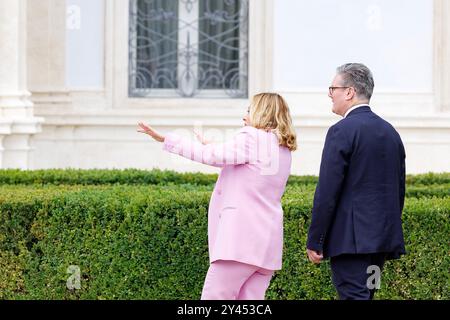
[307,63,405,299]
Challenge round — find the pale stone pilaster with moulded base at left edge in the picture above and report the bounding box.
[0,0,43,169]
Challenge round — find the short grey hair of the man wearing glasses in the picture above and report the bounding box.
[336,63,375,100]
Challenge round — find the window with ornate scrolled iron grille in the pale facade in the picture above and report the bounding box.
[129,0,248,98]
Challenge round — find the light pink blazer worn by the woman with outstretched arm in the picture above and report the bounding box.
[163,126,291,270]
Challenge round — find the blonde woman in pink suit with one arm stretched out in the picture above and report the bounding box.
[138,93,297,300]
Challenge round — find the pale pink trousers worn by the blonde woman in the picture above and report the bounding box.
[201,260,274,300]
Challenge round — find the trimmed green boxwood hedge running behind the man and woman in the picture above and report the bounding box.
[0,170,450,299]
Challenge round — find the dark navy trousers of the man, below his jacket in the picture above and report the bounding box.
[330,253,387,300]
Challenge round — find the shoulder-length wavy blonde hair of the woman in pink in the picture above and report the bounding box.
[249,93,297,151]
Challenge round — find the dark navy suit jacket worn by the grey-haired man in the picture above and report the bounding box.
[307,106,405,259]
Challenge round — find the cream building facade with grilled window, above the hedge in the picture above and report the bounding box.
[0,0,450,174]
